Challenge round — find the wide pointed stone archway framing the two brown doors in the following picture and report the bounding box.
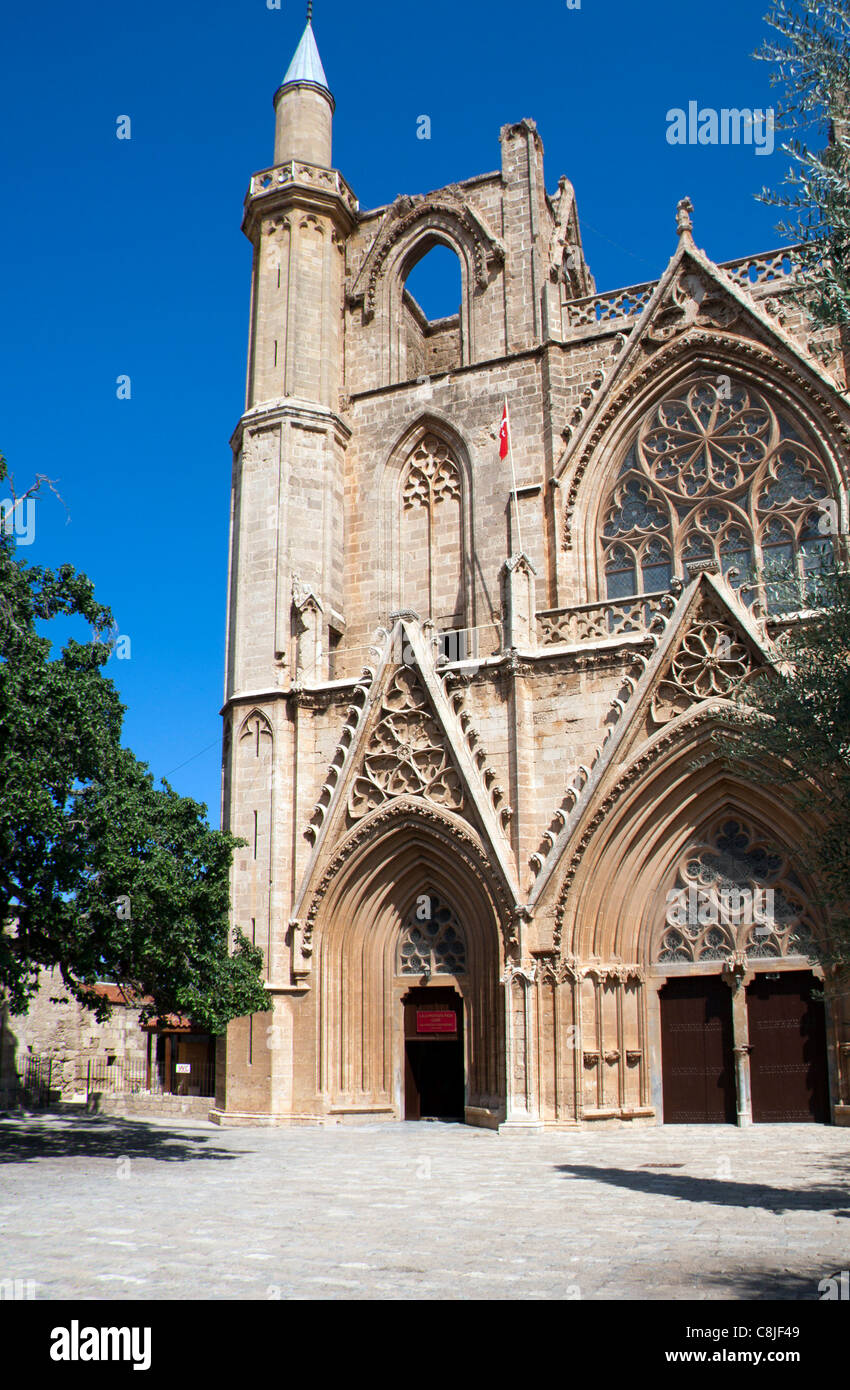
[547,709,842,1115]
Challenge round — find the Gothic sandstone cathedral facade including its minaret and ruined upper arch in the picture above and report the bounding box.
[213,25,850,1131]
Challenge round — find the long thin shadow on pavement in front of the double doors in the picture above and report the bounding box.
[557,1163,850,1216]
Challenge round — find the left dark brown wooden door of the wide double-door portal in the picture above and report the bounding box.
[660,974,736,1125]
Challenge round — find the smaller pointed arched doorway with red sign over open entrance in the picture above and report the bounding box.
[315,806,504,1127]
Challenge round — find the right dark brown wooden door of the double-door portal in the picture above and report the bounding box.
[747,970,829,1125]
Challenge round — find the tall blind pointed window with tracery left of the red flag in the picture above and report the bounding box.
[381,416,475,630]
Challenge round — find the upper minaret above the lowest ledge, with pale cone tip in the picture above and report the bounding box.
[228,13,357,695]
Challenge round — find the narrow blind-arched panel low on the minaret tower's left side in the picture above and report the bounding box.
[231,709,275,979]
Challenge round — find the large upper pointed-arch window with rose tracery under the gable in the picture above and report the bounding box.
[565,334,847,602]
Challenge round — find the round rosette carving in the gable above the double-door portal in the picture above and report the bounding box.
[653,620,754,724]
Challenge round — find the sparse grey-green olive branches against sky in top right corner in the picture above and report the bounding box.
[754,0,850,332]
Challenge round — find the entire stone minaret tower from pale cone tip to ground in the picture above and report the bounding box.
[217,15,357,1113]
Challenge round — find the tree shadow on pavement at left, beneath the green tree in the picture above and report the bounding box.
[0,1115,244,1163]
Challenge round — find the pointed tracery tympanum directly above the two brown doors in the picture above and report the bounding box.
[657,817,817,965]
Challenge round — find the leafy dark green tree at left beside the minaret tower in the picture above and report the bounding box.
[0,456,269,1033]
